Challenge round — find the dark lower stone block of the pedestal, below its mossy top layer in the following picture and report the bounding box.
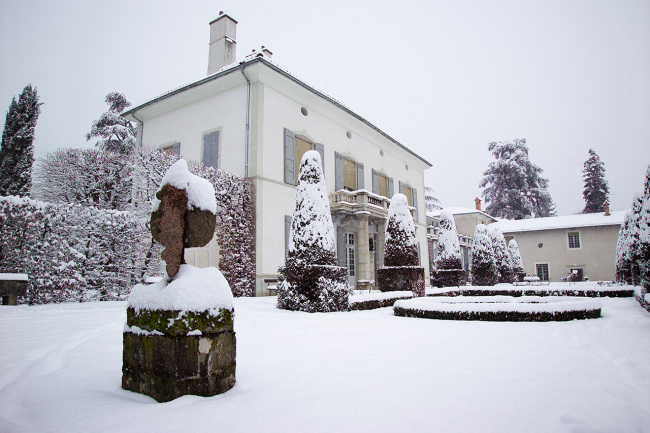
[122,331,236,402]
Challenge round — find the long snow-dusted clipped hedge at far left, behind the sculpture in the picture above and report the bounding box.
[0,196,147,304]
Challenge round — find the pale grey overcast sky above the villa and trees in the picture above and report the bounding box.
[0,0,650,215]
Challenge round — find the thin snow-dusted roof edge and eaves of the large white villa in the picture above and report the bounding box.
[122,53,432,167]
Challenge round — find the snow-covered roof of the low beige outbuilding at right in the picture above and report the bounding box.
[494,210,627,233]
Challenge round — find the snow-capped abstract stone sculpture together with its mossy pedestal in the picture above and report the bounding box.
[122,160,236,402]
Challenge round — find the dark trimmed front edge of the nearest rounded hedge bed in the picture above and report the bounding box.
[393,307,601,322]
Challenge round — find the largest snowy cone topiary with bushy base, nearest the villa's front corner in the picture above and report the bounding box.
[278,151,350,312]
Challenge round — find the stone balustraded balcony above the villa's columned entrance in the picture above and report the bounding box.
[329,189,415,220]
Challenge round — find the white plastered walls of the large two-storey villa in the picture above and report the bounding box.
[125,17,430,296]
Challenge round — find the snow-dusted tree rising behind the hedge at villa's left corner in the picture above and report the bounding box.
[86,92,136,154]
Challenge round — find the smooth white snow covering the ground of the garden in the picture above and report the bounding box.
[0,284,650,433]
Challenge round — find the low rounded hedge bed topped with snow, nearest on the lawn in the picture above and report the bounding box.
[393,296,602,322]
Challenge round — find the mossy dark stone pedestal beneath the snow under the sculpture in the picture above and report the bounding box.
[122,308,236,402]
